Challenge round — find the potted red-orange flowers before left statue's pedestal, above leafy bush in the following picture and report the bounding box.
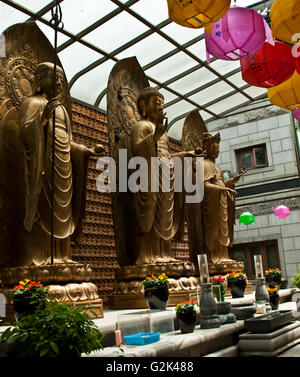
[12,279,49,321]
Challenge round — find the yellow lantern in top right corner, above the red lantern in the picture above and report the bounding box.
[270,0,300,43]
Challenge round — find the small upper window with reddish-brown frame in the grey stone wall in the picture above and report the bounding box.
[235,144,268,170]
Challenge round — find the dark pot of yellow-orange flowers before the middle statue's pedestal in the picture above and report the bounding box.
[142,273,169,310]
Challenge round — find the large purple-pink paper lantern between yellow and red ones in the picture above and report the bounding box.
[205,6,274,62]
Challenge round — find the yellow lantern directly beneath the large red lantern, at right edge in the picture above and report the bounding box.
[268,71,300,111]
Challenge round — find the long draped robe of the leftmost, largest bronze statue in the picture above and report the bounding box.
[20,95,88,265]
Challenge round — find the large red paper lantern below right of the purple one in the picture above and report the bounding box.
[241,41,296,88]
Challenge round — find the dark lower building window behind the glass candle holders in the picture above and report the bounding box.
[228,240,281,280]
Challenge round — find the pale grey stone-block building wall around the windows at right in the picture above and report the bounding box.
[208,103,300,283]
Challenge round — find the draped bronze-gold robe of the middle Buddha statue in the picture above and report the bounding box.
[131,120,184,264]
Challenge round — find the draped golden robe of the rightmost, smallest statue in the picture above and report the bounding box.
[202,159,235,263]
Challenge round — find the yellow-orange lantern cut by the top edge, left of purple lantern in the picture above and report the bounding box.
[168,0,231,28]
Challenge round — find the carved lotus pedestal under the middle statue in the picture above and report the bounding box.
[109,262,200,310]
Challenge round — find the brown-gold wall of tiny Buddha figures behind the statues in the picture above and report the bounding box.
[72,101,189,307]
